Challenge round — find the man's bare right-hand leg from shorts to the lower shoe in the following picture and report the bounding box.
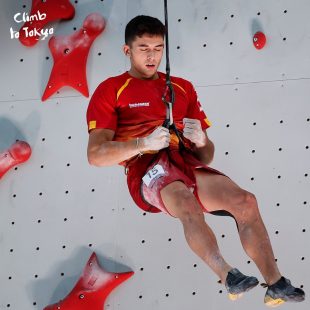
[195,169,281,285]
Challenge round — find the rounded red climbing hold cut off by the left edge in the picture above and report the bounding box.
[0,141,31,179]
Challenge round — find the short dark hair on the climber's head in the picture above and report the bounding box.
[125,15,166,45]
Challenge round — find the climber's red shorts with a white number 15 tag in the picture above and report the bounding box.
[127,149,224,214]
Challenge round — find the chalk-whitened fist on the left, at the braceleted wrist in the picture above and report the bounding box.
[139,126,170,152]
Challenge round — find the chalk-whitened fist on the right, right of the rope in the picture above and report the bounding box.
[183,118,207,147]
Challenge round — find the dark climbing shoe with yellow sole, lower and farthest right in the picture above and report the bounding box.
[262,277,305,307]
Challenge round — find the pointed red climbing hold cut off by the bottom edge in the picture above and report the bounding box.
[44,252,134,310]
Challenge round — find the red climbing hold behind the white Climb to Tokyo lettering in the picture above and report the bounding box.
[19,0,75,46]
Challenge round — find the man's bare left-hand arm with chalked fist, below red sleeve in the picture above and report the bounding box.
[87,127,170,167]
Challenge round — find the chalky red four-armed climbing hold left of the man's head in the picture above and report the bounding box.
[42,13,105,101]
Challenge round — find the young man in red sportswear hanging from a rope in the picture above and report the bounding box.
[87,16,305,306]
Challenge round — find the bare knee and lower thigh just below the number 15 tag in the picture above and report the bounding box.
[162,184,203,222]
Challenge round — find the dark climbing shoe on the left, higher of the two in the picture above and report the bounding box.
[225,268,258,300]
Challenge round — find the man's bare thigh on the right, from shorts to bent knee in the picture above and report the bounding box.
[194,169,252,215]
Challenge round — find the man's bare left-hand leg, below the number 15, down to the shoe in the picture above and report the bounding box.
[161,181,232,283]
